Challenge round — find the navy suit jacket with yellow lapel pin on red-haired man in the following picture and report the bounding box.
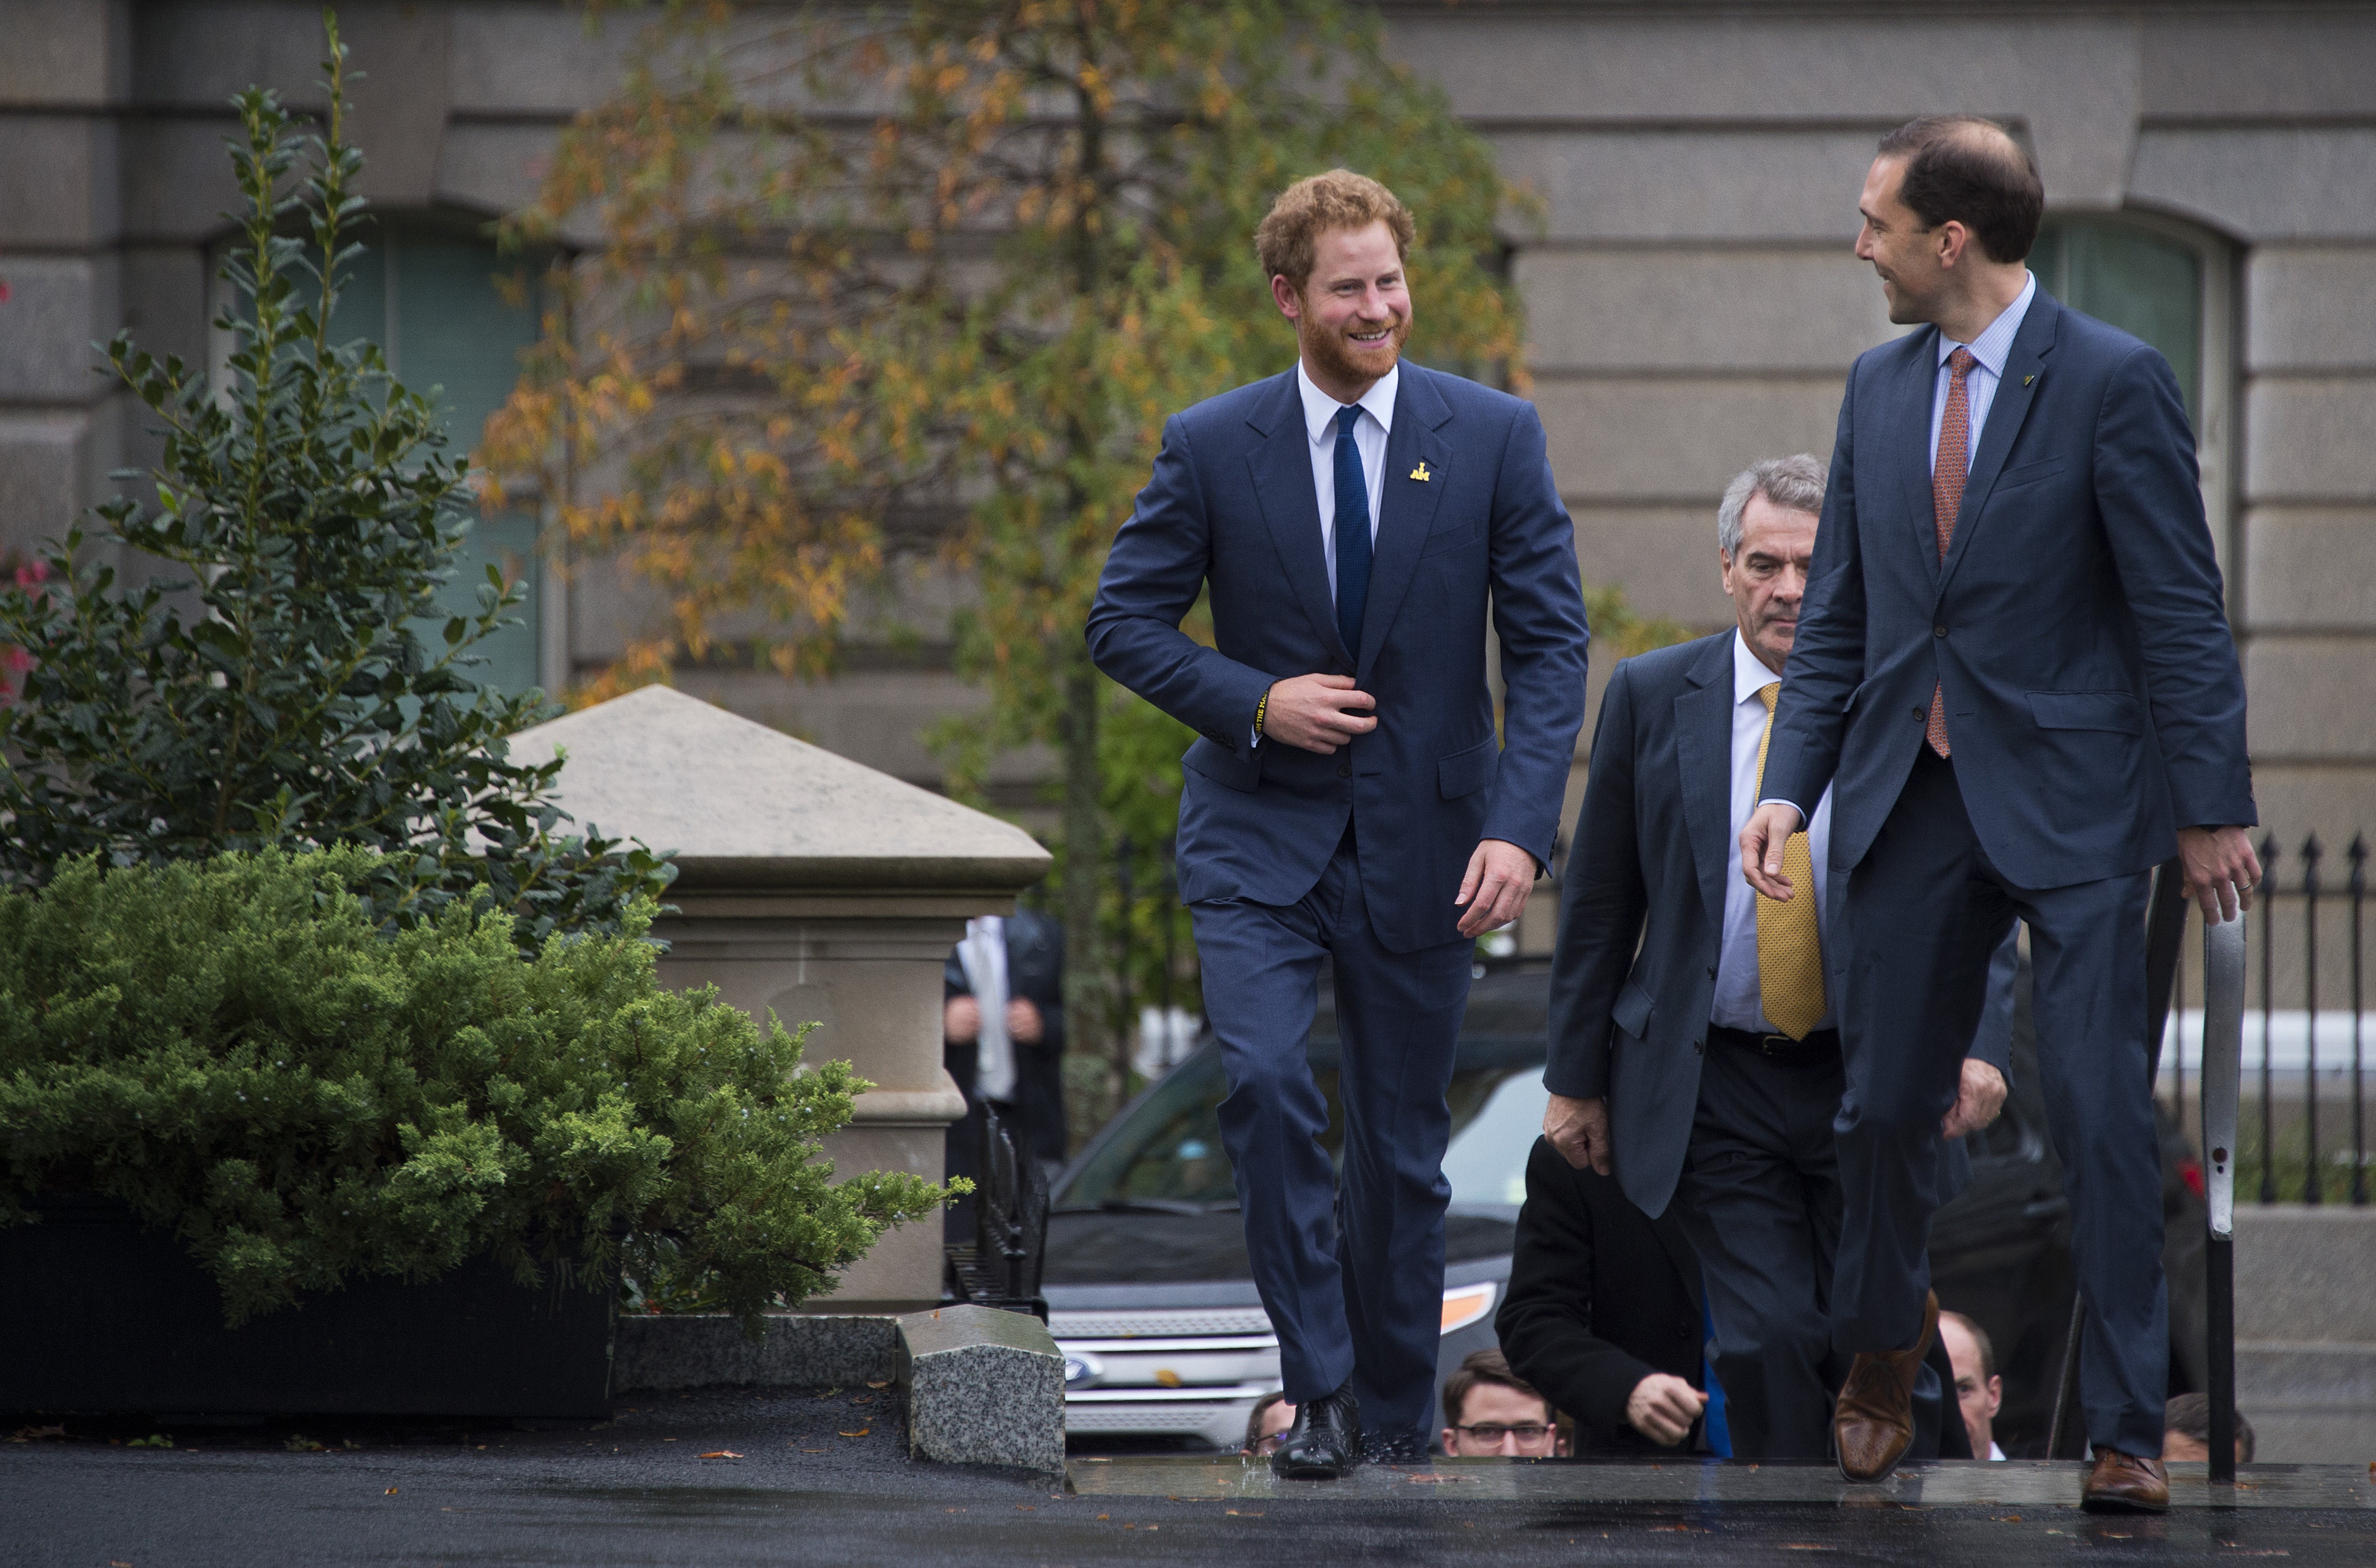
[1088,361,1587,953]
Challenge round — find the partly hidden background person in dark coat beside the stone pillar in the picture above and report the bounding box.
[941,910,1067,1238]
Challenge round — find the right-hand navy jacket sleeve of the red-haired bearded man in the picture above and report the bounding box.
[1483,404,1592,867]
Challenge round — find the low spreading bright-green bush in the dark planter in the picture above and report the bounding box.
[0,848,948,1333]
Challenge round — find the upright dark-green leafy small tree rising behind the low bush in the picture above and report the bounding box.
[0,17,672,948]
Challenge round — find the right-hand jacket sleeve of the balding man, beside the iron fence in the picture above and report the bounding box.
[2096,344,2260,827]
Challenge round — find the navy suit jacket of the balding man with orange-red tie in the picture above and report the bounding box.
[1765,290,2257,889]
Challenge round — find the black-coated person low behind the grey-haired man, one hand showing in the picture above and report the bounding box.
[1495,1138,1972,1459]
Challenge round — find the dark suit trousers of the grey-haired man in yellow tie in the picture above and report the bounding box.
[1675,1043,1970,1459]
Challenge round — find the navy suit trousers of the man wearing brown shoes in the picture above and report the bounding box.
[1832,746,2169,1456]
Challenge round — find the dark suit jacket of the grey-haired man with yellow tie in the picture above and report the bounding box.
[1542,632,2017,1216]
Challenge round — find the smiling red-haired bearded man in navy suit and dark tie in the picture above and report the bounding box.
[1088,169,1587,1475]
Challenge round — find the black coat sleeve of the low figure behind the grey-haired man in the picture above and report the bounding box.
[1495,1138,1658,1447]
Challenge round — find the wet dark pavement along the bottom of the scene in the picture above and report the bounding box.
[14,1390,2376,1568]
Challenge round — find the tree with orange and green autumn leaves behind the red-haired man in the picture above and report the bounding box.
[487,0,1597,1088]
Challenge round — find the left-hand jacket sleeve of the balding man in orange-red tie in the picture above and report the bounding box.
[1763,359,1865,815]
